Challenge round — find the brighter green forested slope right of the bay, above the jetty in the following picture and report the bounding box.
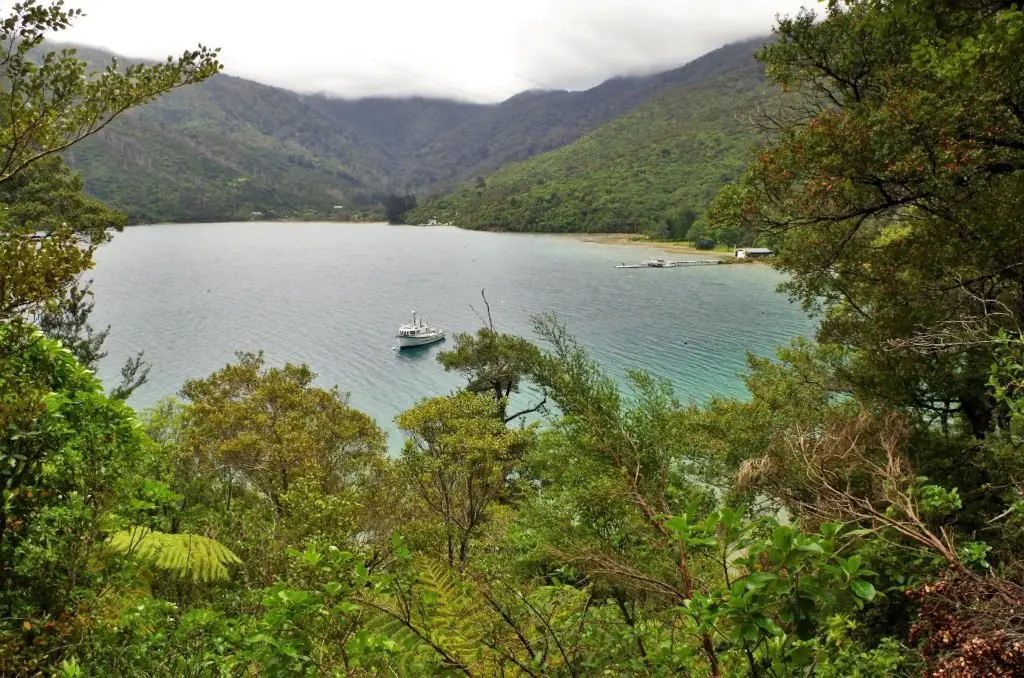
[410,62,768,232]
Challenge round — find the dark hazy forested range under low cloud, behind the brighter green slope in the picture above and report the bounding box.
[54,39,763,222]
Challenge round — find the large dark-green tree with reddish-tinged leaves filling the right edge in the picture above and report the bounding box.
[710,0,1024,436]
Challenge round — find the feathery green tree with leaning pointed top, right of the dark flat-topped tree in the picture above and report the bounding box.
[526,315,721,676]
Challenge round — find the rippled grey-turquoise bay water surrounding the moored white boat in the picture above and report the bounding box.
[92,223,813,447]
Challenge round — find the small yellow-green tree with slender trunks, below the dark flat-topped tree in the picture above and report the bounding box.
[396,392,534,567]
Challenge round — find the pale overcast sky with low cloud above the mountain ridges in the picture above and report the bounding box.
[60,0,816,101]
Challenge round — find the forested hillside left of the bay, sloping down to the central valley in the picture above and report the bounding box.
[60,48,387,221]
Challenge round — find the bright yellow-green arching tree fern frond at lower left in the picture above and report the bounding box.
[110,526,242,583]
